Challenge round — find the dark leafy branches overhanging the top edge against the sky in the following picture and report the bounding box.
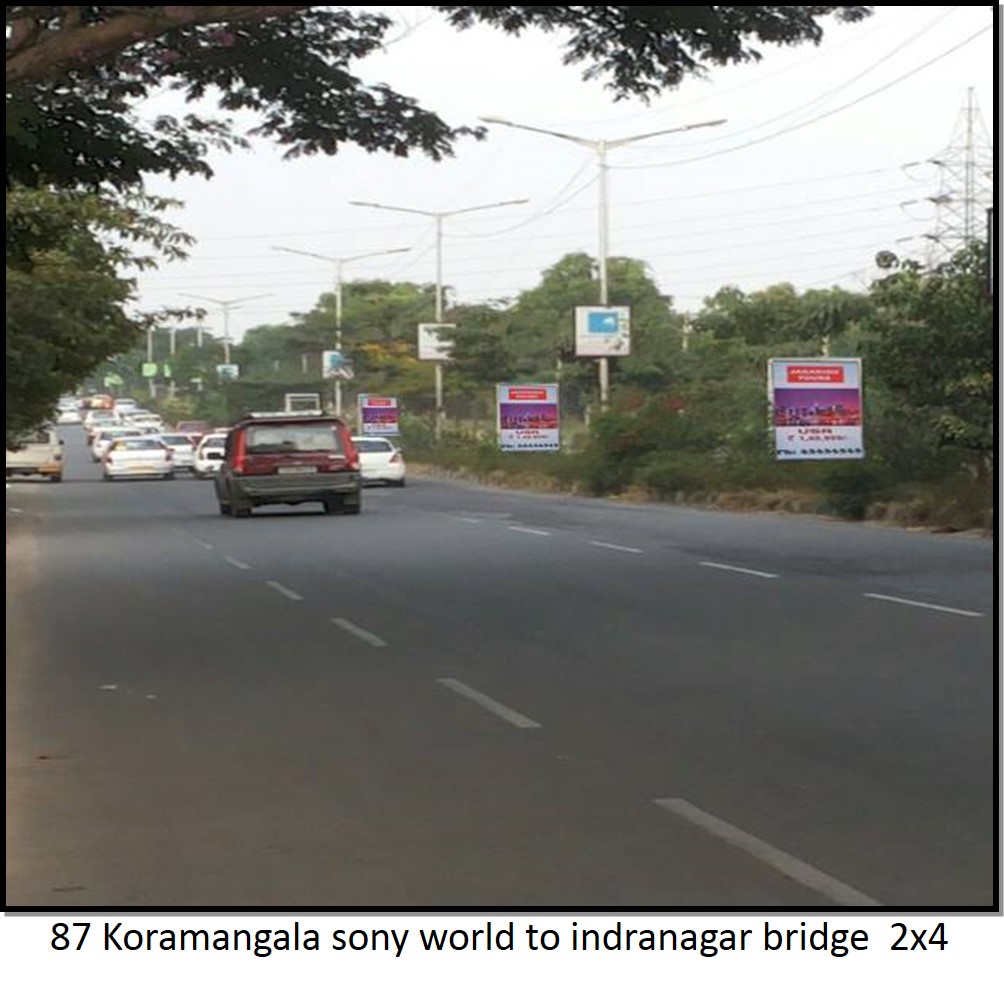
[6,5,871,188]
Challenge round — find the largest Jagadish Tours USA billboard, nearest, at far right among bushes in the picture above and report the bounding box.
[767,359,864,461]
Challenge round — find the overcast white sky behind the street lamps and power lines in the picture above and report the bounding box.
[140,6,996,338]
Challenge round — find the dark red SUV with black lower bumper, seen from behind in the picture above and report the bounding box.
[214,412,362,517]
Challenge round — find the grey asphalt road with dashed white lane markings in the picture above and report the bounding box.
[7,428,998,911]
